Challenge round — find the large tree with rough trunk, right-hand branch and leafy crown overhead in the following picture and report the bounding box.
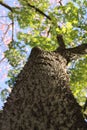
[0,0,87,130]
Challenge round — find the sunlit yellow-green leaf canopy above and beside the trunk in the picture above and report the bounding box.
[0,0,87,129]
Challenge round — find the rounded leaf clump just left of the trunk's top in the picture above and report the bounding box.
[5,42,25,67]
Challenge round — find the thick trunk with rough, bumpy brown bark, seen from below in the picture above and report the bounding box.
[1,48,87,130]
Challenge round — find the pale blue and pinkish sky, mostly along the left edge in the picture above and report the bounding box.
[0,0,70,109]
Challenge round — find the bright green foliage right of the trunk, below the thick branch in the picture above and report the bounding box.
[71,57,87,105]
